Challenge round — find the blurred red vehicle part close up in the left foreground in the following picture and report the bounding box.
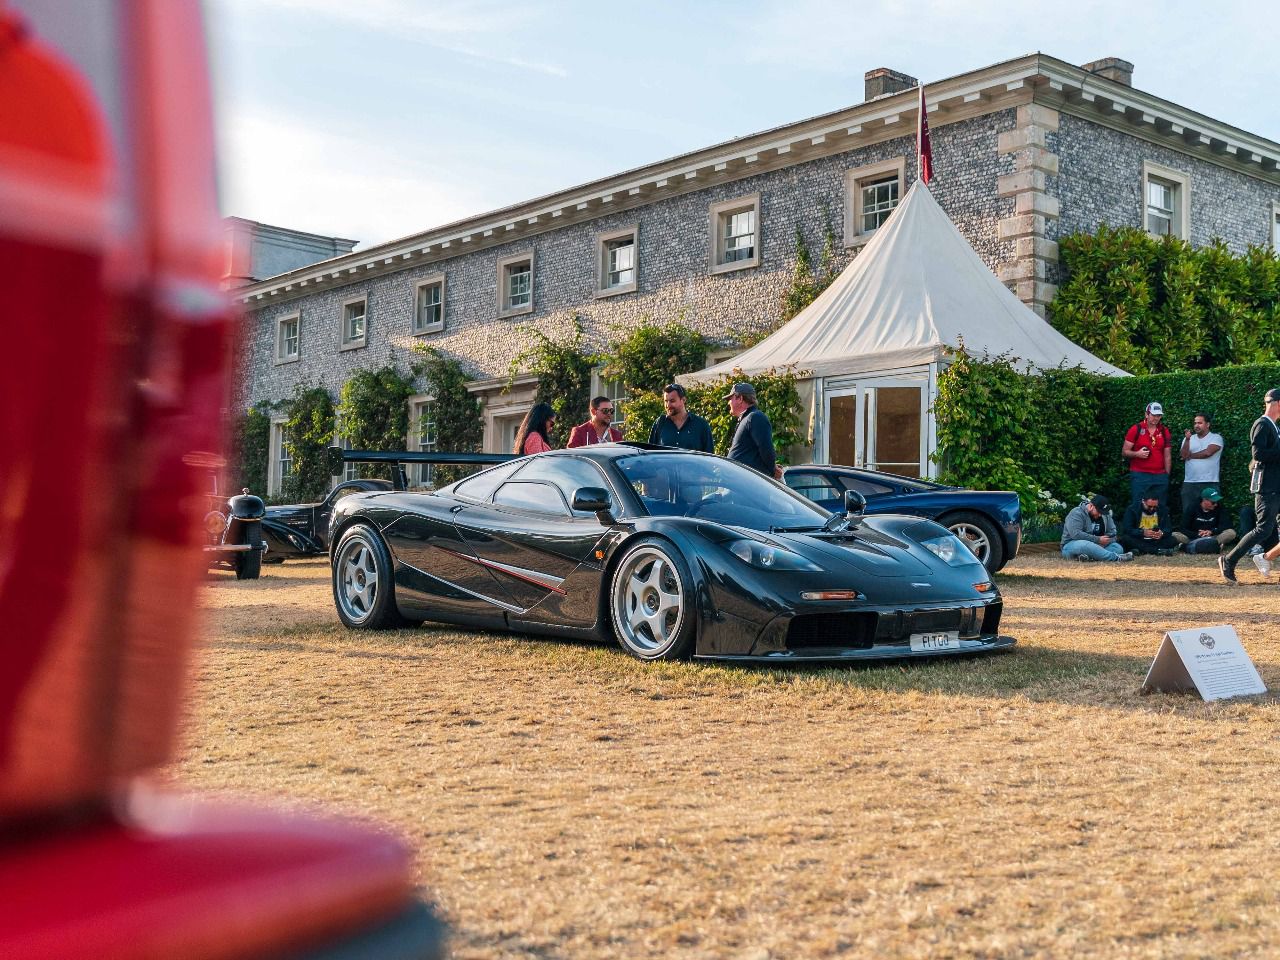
[0,0,439,960]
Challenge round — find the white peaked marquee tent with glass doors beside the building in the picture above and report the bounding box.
[681,182,1128,476]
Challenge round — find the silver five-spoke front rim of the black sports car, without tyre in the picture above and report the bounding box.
[613,544,689,657]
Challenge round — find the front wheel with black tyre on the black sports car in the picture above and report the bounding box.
[609,538,696,660]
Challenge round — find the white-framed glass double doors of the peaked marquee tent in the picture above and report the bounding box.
[826,374,929,477]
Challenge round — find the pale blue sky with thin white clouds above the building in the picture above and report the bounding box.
[205,0,1280,250]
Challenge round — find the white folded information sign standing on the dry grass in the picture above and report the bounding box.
[1142,625,1267,700]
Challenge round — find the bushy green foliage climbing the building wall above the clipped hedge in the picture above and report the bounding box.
[1050,224,1280,374]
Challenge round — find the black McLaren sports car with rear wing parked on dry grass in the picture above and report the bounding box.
[329,443,1014,662]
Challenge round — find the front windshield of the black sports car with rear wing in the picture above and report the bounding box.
[614,453,831,530]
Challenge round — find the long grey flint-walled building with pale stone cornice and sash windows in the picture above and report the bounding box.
[236,54,1280,488]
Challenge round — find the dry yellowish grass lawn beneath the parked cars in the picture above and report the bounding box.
[175,556,1280,959]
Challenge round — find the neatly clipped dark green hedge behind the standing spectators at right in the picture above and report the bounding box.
[1094,364,1280,516]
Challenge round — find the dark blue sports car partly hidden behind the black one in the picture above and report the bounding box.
[782,463,1023,572]
